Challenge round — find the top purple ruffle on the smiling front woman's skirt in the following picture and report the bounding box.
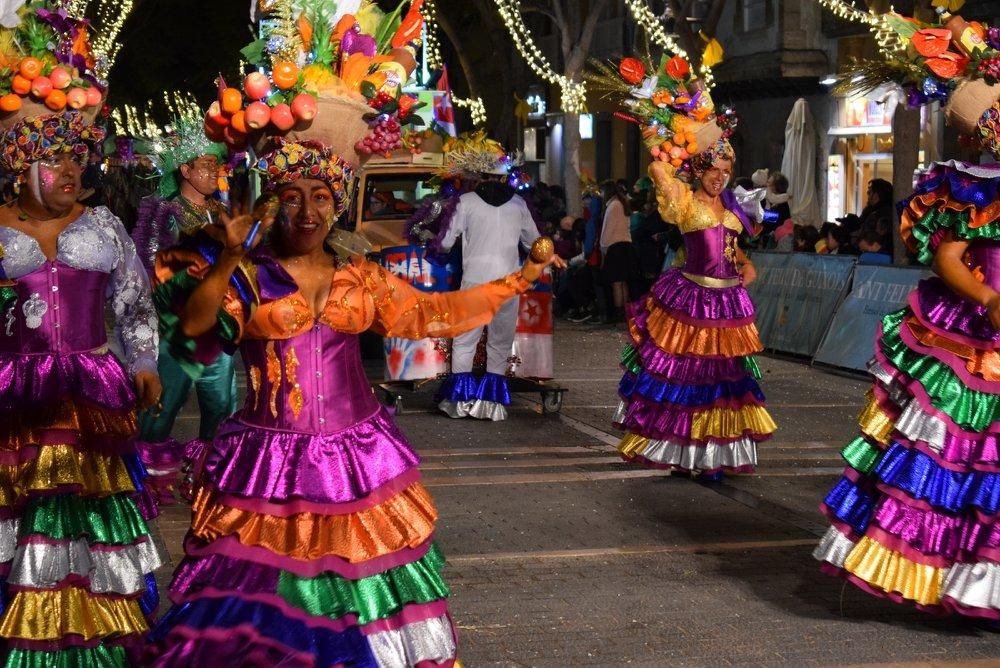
[204,408,420,503]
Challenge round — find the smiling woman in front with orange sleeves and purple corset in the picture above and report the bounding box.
[150,6,552,667]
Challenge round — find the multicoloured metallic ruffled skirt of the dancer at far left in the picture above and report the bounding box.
[0,352,164,668]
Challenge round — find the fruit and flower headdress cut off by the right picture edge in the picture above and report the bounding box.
[834,9,1000,158]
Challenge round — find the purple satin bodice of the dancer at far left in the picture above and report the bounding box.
[0,261,110,354]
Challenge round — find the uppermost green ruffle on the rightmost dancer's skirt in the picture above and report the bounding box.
[880,309,1000,431]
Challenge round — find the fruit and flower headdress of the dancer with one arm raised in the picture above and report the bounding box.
[587,55,736,179]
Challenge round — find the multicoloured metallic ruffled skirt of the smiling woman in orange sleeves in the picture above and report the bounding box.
[151,408,457,667]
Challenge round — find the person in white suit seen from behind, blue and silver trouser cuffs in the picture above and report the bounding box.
[437,142,539,421]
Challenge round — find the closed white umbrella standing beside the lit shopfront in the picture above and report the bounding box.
[781,97,822,225]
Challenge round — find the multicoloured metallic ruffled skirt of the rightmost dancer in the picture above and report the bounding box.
[814,278,1000,619]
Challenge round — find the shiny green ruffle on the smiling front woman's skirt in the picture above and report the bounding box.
[278,545,449,624]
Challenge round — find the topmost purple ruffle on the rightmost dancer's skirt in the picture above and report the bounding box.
[910,278,1000,349]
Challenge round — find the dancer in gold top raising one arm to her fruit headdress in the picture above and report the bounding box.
[592,56,775,479]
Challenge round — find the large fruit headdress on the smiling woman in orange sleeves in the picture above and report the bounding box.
[204,0,423,206]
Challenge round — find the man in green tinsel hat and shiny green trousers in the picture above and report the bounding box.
[132,116,236,503]
